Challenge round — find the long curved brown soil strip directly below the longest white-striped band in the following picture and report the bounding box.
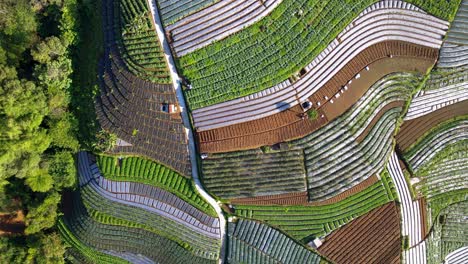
[197,55,436,153]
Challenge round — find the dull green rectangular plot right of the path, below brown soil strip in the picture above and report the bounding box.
[202,150,306,199]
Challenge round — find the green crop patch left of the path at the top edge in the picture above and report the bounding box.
[114,0,171,83]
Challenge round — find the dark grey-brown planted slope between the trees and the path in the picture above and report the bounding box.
[95,0,191,177]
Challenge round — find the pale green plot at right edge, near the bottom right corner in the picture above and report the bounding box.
[427,200,468,264]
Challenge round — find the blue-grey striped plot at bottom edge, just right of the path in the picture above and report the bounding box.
[227,219,321,264]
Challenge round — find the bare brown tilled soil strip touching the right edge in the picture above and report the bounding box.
[396,100,468,152]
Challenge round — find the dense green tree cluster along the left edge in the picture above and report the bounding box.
[0,0,79,263]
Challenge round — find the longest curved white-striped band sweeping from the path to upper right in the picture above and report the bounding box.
[193,1,448,131]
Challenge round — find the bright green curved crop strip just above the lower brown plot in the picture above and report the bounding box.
[235,182,390,242]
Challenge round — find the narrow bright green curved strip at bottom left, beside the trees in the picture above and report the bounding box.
[57,219,129,264]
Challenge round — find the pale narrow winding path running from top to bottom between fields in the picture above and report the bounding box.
[148,0,226,263]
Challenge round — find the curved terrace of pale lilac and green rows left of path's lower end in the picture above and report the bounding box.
[78,152,220,259]
